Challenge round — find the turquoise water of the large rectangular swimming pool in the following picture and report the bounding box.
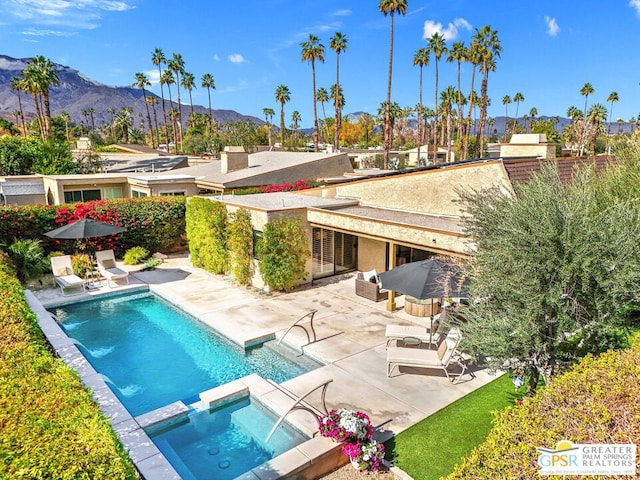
[53,293,318,416]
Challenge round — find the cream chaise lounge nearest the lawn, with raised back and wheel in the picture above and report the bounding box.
[387,328,467,381]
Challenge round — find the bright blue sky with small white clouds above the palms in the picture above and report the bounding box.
[0,0,640,127]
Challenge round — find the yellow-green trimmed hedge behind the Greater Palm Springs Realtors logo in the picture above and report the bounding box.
[447,336,640,480]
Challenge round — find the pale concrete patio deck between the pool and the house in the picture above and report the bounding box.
[33,253,495,478]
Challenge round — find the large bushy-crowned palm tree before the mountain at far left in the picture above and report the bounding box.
[23,55,60,140]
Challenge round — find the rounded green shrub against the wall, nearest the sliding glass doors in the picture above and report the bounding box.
[256,218,311,292]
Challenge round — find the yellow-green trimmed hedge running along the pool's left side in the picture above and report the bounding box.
[0,252,138,479]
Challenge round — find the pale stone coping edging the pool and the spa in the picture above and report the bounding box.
[25,286,347,480]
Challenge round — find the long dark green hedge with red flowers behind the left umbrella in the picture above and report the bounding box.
[0,197,186,257]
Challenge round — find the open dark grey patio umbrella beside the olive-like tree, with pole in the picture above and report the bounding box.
[380,258,469,348]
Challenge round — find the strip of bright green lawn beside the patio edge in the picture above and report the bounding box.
[387,374,525,480]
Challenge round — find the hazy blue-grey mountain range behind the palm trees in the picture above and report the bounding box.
[0,55,264,128]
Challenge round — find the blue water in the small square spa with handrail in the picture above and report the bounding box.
[147,398,307,480]
